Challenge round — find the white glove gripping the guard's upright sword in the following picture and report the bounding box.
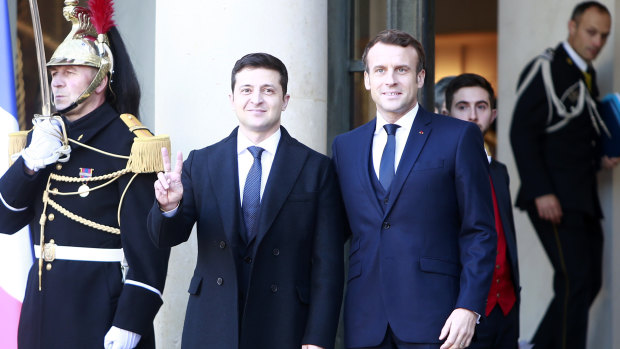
[21,117,71,171]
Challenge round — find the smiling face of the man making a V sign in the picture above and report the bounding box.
[230,67,290,140]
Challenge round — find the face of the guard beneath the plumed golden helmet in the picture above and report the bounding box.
[49,65,97,116]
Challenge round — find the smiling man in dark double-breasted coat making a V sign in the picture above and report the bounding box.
[149,53,344,349]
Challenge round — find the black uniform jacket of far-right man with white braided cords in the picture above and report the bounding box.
[510,44,601,217]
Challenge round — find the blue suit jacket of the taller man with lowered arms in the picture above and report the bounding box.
[333,107,497,348]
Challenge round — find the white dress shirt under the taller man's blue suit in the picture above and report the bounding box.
[372,103,419,178]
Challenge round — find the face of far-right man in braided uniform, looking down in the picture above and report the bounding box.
[568,7,611,63]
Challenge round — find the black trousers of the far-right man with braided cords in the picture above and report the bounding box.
[528,209,603,349]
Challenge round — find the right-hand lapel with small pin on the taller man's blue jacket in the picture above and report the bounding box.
[386,106,432,216]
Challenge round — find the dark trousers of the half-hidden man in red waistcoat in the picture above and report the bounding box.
[468,304,519,349]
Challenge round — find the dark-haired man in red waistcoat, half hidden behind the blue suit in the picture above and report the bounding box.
[446,74,520,349]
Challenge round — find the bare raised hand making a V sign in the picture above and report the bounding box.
[154,148,183,211]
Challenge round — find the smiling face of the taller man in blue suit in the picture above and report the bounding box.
[364,42,425,123]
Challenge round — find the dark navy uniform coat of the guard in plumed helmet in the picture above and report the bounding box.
[0,103,169,348]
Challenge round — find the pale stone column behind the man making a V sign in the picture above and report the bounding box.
[154,0,327,348]
